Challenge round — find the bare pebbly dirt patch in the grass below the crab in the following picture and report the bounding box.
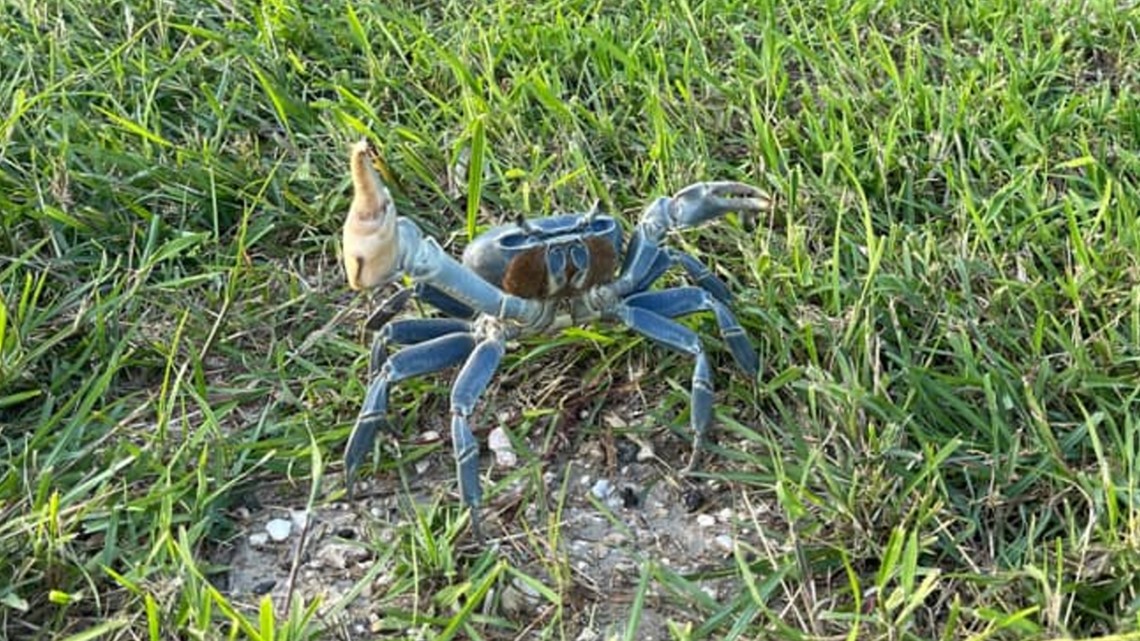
[218,369,783,641]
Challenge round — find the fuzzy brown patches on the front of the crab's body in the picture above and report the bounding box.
[502,237,618,299]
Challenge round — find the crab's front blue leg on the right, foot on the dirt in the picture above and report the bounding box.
[613,305,713,469]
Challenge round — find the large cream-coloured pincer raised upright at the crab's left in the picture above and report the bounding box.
[343,140,400,290]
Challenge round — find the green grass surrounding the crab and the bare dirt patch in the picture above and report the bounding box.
[0,0,1140,640]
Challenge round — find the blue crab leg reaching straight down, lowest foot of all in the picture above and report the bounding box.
[451,338,505,538]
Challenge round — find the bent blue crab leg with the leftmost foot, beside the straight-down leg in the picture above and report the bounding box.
[344,332,475,501]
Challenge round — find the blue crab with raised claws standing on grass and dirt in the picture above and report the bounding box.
[343,140,771,538]
